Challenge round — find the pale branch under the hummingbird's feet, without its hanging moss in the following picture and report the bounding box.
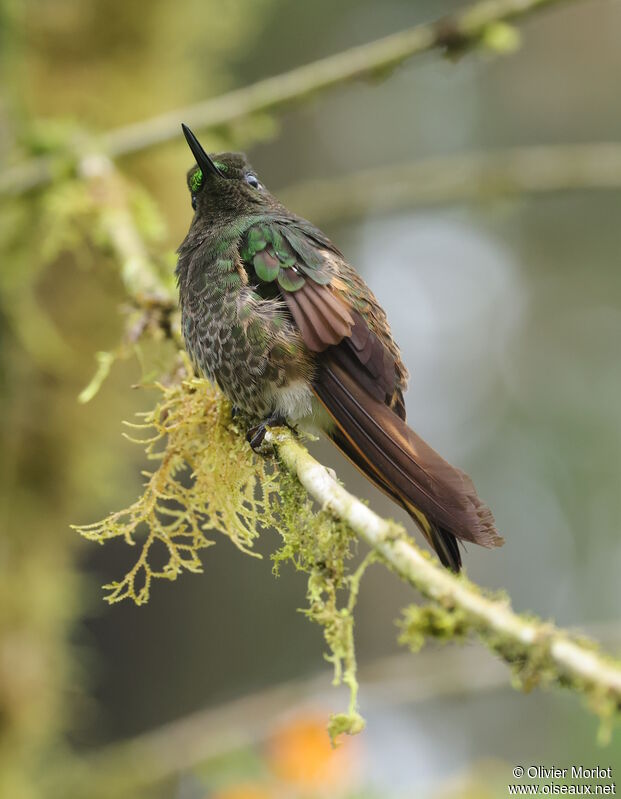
[266,430,621,709]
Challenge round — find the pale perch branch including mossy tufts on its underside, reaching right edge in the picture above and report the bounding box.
[266,431,621,740]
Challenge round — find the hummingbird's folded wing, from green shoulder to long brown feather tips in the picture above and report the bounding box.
[241,222,502,571]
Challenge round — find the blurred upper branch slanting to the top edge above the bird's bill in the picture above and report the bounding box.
[0,0,580,196]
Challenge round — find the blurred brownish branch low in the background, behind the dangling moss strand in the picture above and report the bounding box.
[52,625,621,799]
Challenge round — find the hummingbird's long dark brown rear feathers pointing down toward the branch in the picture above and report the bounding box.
[313,360,503,572]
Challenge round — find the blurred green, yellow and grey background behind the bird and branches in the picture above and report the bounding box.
[0,0,621,799]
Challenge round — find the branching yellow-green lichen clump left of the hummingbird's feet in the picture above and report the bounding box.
[76,378,275,605]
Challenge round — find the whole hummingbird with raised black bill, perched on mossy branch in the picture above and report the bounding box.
[176,125,503,572]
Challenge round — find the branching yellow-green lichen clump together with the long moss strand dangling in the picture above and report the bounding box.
[76,375,375,741]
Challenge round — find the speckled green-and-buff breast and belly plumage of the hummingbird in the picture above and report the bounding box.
[178,212,312,418]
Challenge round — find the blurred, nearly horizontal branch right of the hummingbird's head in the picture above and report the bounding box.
[279,142,621,223]
